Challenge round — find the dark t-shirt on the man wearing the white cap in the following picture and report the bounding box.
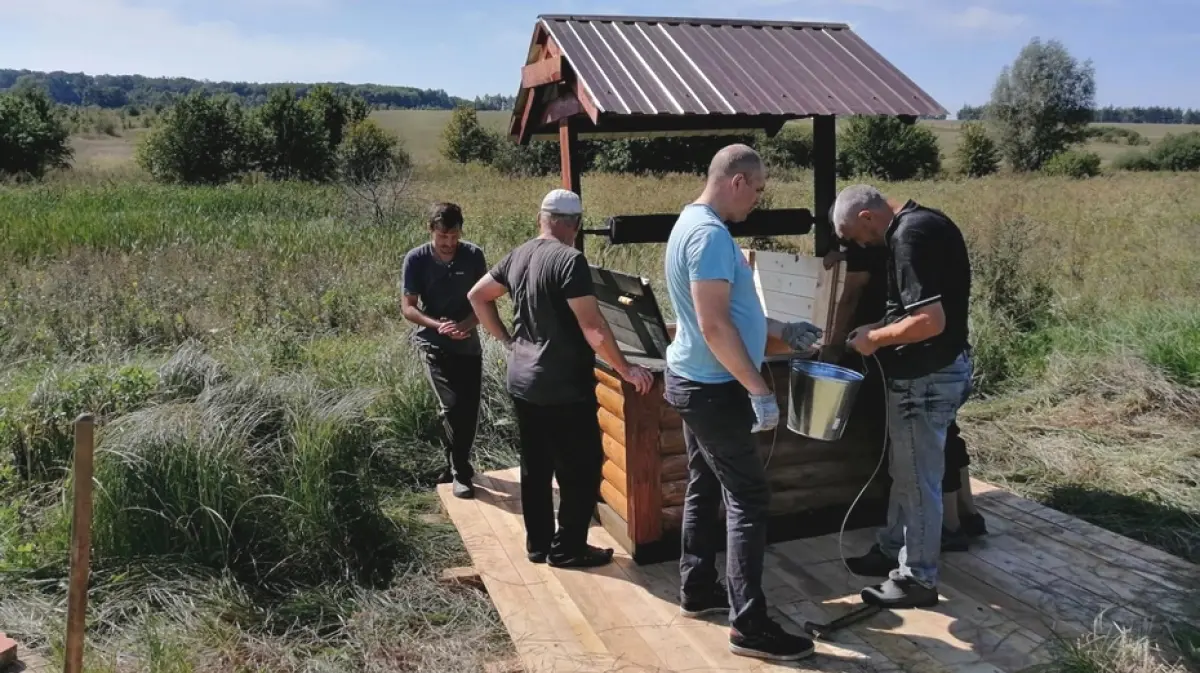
[491,239,596,404]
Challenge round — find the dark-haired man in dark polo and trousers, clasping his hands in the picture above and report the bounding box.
[402,203,487,498]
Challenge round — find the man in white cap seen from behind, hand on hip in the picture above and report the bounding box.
[469,190,654,567]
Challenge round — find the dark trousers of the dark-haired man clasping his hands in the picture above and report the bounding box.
[421,345,484,483]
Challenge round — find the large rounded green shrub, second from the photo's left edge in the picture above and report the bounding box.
[137,92,256,185]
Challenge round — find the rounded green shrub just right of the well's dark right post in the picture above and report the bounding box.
[838,115,942,180]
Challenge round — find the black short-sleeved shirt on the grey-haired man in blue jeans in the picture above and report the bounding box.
[880,200,971,379]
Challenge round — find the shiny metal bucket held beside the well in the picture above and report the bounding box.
[787,359,863,441]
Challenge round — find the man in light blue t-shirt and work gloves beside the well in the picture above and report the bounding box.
[664,145,821,661]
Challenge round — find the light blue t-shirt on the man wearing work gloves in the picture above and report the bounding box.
[666,204,767,383]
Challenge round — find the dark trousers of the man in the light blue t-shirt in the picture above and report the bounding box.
[664,369,770,632]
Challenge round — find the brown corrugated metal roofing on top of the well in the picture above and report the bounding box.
[539,14,947,116]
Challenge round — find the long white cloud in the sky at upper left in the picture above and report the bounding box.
[0,0,378,82]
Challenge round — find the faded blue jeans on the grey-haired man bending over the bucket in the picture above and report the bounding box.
[877,353,972,587]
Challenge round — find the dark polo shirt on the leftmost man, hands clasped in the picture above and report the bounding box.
[402,241,487,355]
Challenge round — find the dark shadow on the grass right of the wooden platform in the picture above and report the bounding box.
[1043,485,1200,563]
